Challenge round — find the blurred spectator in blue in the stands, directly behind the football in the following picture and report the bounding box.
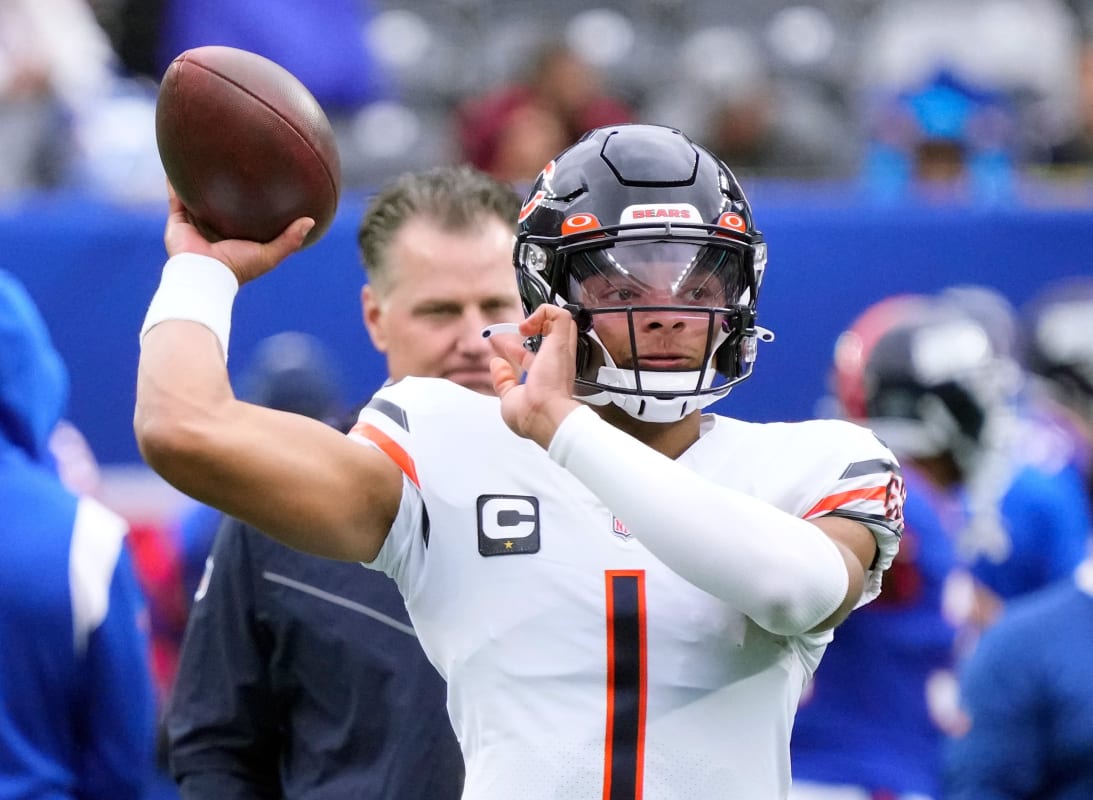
[160,0,395,186]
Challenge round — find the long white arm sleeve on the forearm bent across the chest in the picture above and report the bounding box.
[549,407,849,635]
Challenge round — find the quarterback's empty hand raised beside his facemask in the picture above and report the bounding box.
[490,304,580,449]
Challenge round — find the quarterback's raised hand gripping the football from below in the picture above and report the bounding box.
[163,181,315,285]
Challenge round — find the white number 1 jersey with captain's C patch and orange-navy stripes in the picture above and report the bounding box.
[351,378,898,800]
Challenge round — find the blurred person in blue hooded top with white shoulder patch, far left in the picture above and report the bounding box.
[0,271,155,800]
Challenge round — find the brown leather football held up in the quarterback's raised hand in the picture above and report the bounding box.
[155,46,341,247]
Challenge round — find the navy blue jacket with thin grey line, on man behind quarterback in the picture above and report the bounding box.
[167,519,463,800]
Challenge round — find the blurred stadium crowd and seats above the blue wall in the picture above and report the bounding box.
[8,0,1093,199]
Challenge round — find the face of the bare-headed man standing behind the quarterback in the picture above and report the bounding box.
[361,216,524,395]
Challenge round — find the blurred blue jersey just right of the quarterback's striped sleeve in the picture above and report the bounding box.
[790,464,956,797]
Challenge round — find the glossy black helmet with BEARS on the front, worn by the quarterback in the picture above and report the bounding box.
[515,125,772,422]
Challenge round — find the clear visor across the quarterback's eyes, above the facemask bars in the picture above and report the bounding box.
[568,242,748,310]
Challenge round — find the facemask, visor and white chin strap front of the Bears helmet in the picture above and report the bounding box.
[518,225,765,423]
